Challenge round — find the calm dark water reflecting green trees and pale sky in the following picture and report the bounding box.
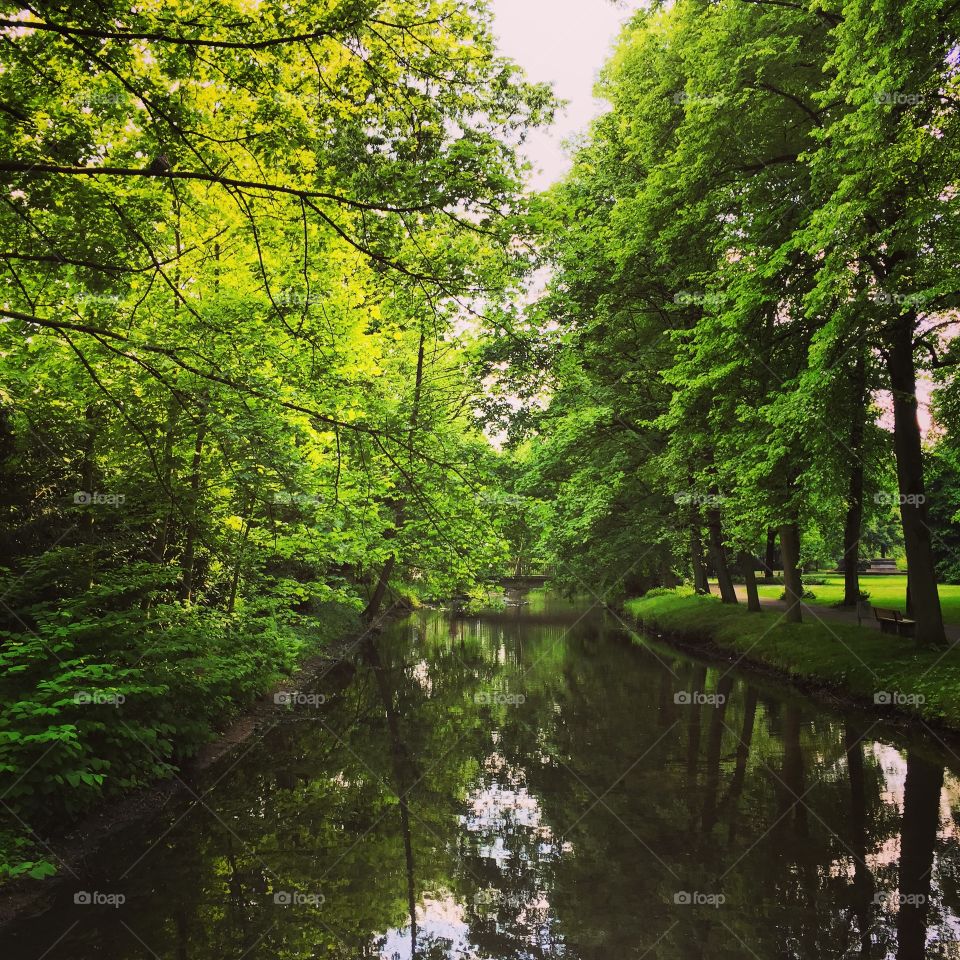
[0,597,960,960]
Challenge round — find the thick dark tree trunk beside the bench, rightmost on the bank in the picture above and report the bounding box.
[887,313,946,645]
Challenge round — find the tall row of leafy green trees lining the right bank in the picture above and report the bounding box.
[513,0,960,644]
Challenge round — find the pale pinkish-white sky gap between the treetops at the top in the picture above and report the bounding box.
[491,0,640,190]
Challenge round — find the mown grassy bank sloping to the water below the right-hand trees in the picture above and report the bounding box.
[625,592,960,730]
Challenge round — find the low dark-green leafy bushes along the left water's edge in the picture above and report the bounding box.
[0,569,355,882]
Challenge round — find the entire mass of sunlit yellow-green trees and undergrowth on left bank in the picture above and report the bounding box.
[0,0,552,876]
